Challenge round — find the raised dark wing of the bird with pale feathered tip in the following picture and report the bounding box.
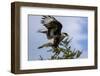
[41,16,62,39]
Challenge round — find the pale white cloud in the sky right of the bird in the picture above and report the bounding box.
[56,17,87,50]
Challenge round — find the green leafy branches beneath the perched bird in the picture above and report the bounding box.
[40,37,82,60]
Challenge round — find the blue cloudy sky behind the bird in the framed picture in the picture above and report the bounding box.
[28,15,88,60]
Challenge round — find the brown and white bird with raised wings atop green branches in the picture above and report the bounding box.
[38,16,68,49]
